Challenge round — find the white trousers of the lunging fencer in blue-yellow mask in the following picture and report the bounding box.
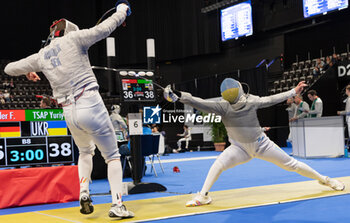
[201,134,325,195]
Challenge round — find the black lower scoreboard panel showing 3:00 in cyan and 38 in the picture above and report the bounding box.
[0,136,74,167]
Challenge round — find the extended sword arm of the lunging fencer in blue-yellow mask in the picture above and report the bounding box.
[180,92,230,115]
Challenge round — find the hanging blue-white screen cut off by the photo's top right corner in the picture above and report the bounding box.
[303,0,349,18]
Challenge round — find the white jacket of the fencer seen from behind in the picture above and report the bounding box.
[5,4,128,103]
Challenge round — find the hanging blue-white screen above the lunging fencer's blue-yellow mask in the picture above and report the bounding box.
[220,1,253,41]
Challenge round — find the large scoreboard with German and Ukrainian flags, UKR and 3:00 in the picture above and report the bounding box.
[0,109,74,167]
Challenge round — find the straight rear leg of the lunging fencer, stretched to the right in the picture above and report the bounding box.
[257,137,344,190]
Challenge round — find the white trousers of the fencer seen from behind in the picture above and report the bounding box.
[63,90,120,163]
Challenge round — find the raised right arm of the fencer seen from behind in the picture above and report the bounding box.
[72,4,129,48]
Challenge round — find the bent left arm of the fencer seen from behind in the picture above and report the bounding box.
[4,53,41,76]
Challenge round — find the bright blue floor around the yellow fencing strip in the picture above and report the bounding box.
[0,148,350,223]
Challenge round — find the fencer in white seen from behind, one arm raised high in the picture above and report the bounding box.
[5,0,134,218]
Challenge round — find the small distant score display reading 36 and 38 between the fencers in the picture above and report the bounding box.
[121,78,156,102]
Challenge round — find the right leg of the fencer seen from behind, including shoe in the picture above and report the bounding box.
[76,90,134,218]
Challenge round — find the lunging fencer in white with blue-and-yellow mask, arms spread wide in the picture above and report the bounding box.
[164,78,345,207]
